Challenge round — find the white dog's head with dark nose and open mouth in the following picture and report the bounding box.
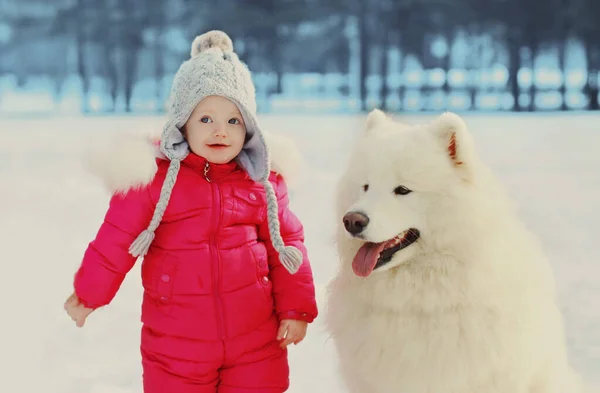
[338,110,476,277]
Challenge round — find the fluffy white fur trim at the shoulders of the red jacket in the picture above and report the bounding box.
[82,130,303,194]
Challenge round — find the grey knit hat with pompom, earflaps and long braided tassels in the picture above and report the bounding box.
[129,30,303,274]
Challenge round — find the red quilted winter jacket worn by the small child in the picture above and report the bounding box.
[75,153,317,340]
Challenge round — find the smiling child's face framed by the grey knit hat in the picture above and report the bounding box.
[184,96,246,164]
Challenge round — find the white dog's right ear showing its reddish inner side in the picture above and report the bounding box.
[432,112,475,177]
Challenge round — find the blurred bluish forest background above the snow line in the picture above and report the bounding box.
[0,0,600,115]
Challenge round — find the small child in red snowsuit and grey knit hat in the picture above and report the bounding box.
[65,31,317,393]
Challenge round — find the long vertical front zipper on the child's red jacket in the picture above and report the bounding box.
[204,162,225,340]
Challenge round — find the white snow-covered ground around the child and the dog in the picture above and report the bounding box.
[0,114,600,393]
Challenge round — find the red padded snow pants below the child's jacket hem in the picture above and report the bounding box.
[141,319,289,393]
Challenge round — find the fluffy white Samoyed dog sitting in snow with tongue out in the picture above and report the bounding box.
[326,110,582,393]
